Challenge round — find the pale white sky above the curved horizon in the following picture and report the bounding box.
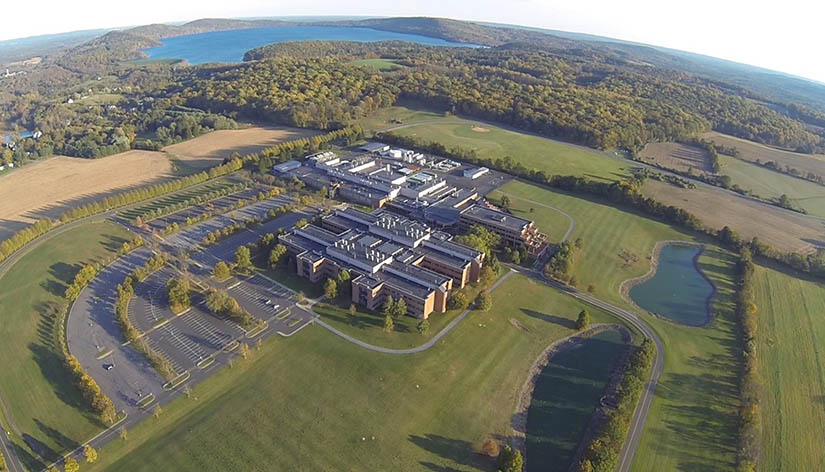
[0,0,825,82]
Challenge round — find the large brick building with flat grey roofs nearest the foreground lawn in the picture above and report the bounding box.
[279,208,484,319]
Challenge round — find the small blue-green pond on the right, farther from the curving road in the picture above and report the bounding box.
[630,244,713,326]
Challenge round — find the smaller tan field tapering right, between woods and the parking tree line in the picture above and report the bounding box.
[163,126,318,167]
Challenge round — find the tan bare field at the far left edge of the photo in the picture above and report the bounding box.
[0,151,171,239]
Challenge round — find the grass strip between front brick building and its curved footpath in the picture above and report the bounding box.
[312,268,496,349]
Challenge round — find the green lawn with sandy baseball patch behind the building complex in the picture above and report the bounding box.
[362,107,629,180]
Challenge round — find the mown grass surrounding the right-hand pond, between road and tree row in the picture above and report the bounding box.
[493,182,738,471]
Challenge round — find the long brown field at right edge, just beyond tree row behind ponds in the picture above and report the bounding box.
[644,180,825,252]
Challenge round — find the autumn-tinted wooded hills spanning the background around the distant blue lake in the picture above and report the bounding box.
[0,18,825,161]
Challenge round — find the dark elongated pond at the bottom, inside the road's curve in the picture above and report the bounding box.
[526,330,623,472]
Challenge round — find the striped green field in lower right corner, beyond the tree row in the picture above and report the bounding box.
[754,266,825,472]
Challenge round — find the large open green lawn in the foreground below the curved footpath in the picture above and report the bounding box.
[85,276,632,471]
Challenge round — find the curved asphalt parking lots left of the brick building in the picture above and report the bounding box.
[53,197,316,472]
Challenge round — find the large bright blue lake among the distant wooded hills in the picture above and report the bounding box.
[143,26,475,64]
